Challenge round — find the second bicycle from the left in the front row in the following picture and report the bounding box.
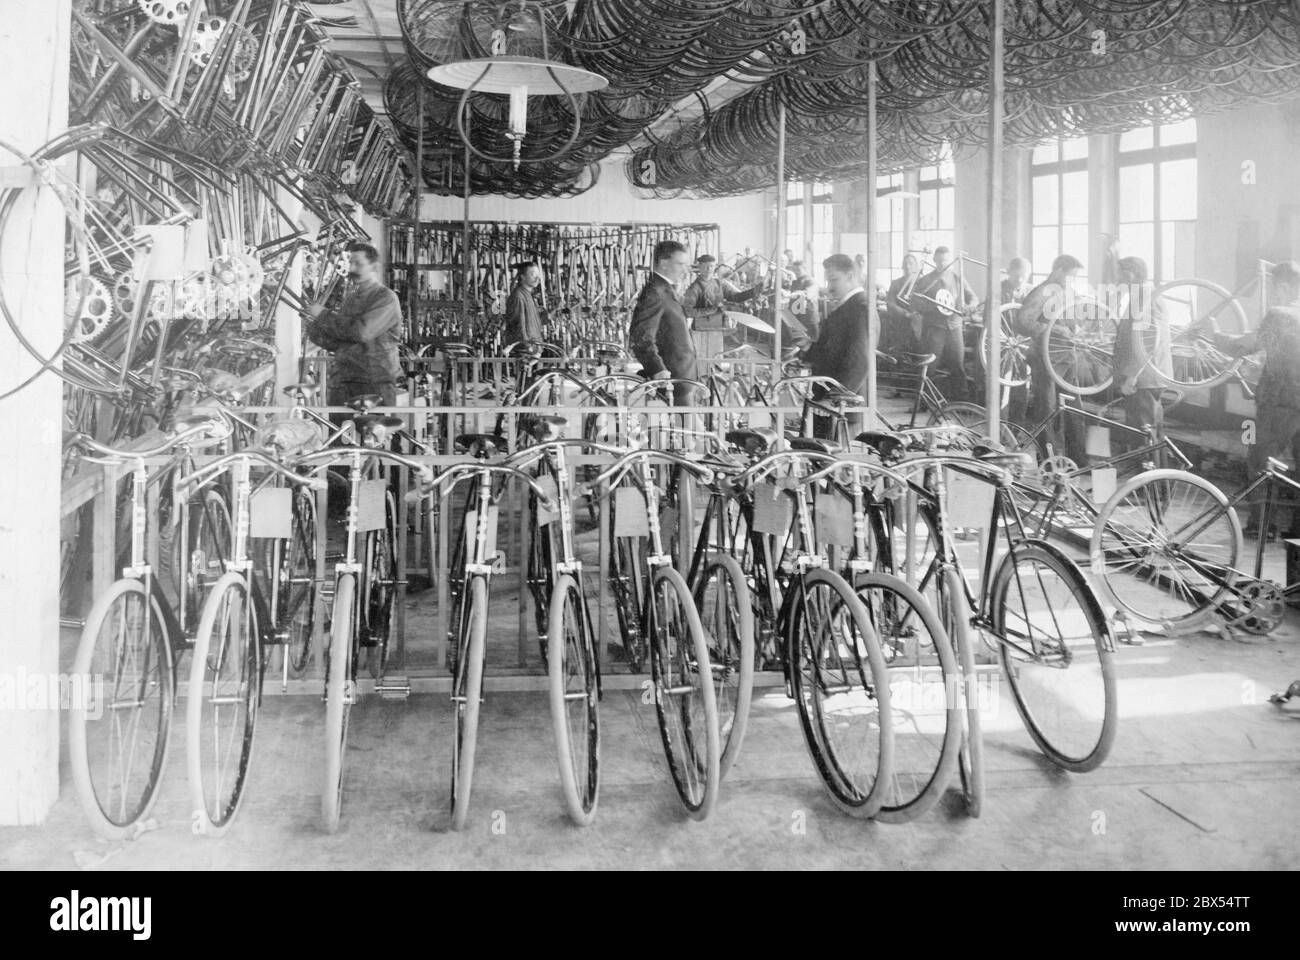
[178,450,325,836]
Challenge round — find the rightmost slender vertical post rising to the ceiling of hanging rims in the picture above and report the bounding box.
[984,0,1005,431]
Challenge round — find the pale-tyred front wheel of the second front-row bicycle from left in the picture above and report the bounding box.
[185,571,261,836]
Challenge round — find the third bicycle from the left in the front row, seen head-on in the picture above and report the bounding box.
[294,446,433,834]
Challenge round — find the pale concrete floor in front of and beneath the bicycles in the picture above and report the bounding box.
[12,390,1300,870]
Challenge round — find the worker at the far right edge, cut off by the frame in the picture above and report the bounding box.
[1190,260,1300,536]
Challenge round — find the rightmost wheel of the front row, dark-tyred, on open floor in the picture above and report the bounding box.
[989,541,1117,773]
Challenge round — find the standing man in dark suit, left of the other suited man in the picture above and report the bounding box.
[628,241,698,407]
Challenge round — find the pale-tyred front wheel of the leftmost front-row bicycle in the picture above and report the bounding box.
[68,580,176,840]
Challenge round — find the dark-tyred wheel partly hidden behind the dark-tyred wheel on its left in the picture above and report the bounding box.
[853,572,962,823]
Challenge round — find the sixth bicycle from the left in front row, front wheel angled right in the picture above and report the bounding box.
[589,450,722,820]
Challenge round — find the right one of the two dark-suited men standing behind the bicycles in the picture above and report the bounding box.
[803,254,871,437]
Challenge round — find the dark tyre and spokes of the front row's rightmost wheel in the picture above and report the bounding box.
[988,540,1118,773]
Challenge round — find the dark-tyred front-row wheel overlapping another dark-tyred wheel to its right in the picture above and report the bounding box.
[787,568,893,818]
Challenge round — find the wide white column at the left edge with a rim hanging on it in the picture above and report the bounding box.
[0,0,73,825]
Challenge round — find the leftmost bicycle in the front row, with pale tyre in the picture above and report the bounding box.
[68,419,229,839]
